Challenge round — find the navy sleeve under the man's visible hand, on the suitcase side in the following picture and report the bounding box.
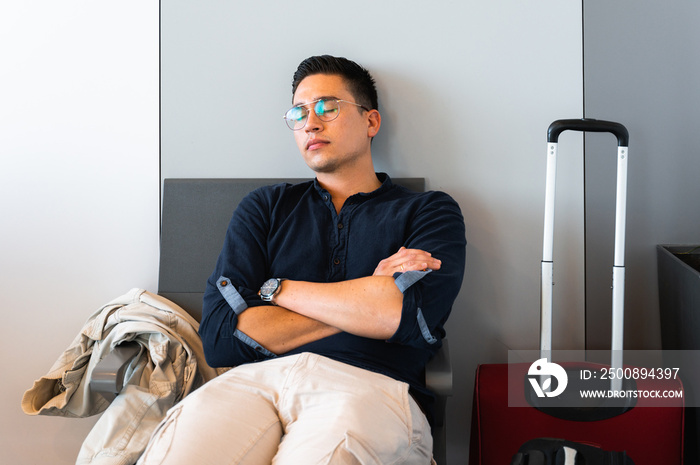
[388,192,467,351]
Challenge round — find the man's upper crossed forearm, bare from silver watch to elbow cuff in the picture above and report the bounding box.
[275,276,403,339]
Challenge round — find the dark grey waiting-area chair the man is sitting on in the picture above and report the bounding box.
[90,178,452,464]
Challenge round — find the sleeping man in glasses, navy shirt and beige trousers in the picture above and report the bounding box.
[141,56,466,465]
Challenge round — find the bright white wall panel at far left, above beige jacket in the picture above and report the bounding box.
[0,0,159,465]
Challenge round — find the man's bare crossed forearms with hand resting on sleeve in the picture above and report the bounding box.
[238,247,441,354]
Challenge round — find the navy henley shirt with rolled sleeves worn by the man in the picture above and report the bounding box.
[199,173,466,420]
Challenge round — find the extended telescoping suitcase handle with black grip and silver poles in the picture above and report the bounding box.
[540,119,629,390]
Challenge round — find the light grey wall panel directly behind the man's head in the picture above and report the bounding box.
[161,0,583,463]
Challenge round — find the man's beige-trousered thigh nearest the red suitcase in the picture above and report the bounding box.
[273,354,432,465]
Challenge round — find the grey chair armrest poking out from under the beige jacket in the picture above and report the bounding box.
[89,341,141,402]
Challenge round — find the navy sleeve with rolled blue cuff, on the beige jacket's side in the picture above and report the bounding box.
[199,191,274,367]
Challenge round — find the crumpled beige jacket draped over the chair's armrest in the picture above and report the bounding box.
[22,289,217,465]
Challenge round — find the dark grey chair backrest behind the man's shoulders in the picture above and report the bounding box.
[158,178,425,321]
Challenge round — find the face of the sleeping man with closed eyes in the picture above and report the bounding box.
[294,74,379,173]
